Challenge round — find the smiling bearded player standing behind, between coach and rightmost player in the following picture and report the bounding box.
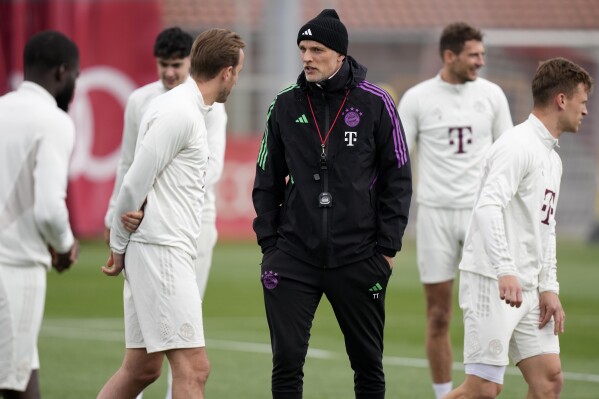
[398,23,512,399]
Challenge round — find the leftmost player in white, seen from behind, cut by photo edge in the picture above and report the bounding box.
[0,31,79,399]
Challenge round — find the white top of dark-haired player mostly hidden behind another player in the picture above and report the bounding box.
[104,78,227,228]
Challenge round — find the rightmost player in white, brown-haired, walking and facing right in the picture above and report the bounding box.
[445,58,593,399]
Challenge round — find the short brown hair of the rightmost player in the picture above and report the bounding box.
[532,57,594,106]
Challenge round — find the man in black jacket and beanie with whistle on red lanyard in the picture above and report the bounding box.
[252,10,412,399]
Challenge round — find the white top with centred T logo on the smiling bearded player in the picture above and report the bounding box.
[398,75,513,209]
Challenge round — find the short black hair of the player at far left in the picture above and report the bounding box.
[23,30,79,76]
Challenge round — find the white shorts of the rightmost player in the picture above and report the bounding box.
[460,271,559,366]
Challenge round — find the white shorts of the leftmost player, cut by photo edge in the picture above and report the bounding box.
[0,265,47,391]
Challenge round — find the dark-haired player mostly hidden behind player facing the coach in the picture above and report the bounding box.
[104,27,227,399]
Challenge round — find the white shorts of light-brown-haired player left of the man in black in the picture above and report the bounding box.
[123,241,206,353]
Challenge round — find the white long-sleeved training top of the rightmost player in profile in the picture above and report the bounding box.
[460,115,562,293]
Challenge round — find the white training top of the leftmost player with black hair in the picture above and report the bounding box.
[0,81,75,268]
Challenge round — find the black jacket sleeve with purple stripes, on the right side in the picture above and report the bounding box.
[375,94,412,256]
